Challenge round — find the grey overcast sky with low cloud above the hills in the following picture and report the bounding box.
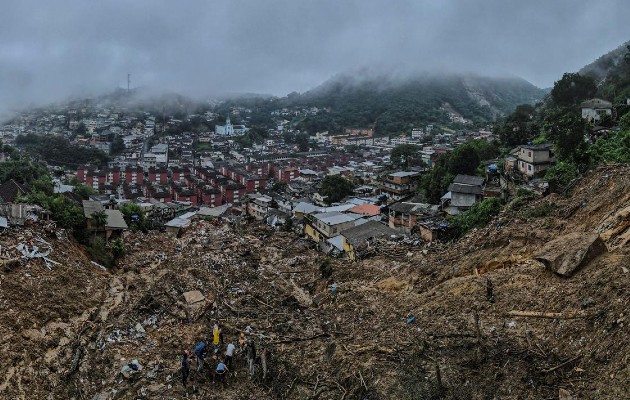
[0,0,630,109]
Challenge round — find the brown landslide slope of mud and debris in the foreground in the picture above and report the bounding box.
[0,166,630,399]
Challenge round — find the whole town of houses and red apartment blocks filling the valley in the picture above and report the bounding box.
[12,93,624,259]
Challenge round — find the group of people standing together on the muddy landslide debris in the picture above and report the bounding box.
[181,321,266,386]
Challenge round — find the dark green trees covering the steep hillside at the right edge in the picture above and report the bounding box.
[495,42,630,189]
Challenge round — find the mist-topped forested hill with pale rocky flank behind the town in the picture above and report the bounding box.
[289,74,545,138]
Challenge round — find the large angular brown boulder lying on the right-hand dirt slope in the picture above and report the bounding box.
[534,232,607,278]
